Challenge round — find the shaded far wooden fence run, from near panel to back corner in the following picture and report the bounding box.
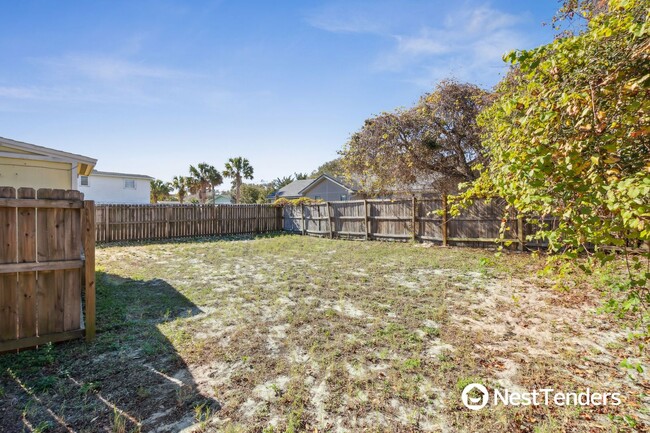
[95,204,282,242]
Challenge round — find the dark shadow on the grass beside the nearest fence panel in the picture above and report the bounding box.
[0,272,220,432]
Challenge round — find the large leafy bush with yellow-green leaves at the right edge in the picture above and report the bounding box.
[456,0,650,332]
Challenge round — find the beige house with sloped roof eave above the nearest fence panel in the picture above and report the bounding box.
[0,137,97,189]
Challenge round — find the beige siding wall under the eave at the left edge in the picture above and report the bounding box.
[0,157,72,189]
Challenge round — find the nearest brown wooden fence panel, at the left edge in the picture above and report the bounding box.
[0,187,95,352]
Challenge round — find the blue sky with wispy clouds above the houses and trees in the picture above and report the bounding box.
[0,0,558,181]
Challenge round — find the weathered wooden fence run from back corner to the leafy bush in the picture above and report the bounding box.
[283,198,543,250]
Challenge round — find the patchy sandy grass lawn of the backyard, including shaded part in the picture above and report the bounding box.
[0,235,650,432]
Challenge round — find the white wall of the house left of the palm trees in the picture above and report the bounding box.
[78,176,151,204]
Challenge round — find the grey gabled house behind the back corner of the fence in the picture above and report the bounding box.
[267,174,358,201]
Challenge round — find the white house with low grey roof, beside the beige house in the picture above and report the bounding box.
[79,170,153,204]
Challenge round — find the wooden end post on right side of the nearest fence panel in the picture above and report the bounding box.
[83,200,95,341]
